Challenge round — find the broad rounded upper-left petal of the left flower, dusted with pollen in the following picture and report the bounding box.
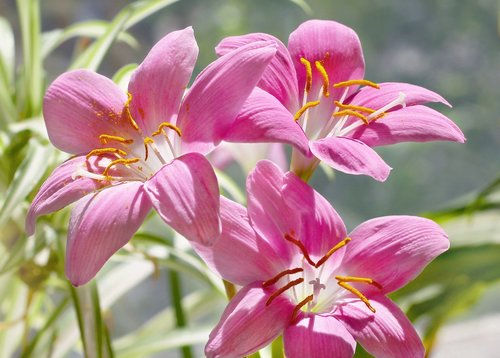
[43,70,132,154]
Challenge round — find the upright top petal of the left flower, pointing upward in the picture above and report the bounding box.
[129,27,198,134]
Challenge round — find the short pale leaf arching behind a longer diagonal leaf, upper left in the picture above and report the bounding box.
[42,20,138,59]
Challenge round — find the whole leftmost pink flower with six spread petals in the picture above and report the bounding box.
[26,28,286,285]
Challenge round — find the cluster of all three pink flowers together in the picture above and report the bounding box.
[26,20,465,358]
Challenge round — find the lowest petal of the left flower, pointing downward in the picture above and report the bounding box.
[66,182,151,286]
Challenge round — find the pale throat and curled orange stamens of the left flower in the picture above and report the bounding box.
[73,93,182,182]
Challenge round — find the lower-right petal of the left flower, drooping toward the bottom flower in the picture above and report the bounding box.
[144,153,221,245]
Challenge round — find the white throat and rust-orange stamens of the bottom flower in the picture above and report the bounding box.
[262,232,382,321]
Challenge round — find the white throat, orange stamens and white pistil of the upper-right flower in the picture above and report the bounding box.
[294,53,406,140]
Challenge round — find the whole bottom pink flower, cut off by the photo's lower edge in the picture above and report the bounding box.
[195,161,449,358]
